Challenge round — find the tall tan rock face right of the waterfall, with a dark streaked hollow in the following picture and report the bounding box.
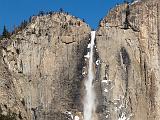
[96,0,160,120]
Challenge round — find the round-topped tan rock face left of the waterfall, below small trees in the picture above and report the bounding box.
[0,13,91,120]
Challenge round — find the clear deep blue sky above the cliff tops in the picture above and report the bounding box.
[0,0,123,33]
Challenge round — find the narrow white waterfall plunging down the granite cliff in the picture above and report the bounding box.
[83,31,95,120]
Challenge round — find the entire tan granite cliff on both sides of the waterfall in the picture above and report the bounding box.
[0,0,160,120]
